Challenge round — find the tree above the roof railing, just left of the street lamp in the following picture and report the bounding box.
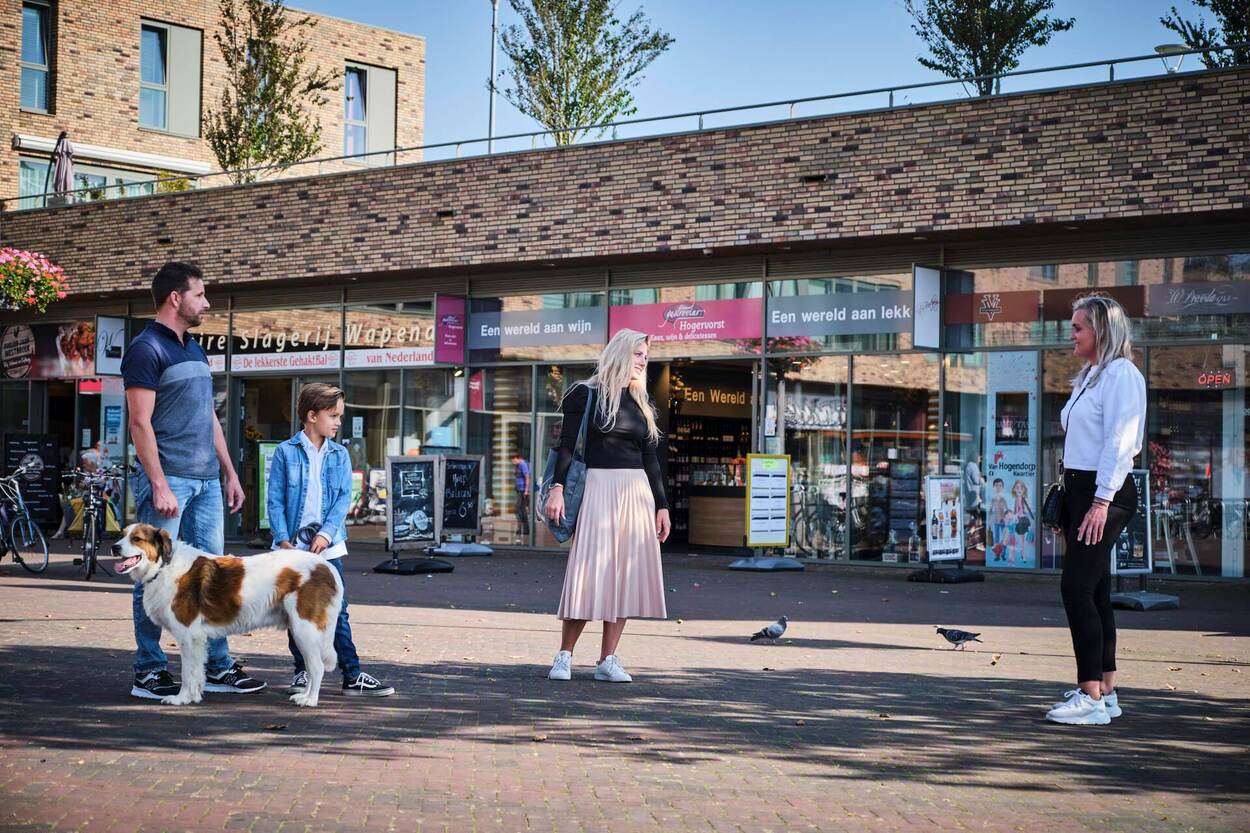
[906,0,1075,95]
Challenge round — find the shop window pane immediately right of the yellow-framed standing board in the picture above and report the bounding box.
[764,356,868,560]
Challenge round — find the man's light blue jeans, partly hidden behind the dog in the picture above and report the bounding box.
[133,470,234,674]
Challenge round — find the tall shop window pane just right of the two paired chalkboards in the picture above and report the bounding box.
[469,366,534,545]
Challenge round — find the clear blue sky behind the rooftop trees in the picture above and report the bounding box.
[289,0,1210,144]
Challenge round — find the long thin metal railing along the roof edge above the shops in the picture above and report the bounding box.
[0,43,1250,213]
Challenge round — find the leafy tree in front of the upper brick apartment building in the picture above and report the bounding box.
[204,0,339,183]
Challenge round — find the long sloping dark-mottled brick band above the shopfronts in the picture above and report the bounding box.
[0,69,1250,293]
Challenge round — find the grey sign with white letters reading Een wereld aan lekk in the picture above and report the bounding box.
[768,290,913,338]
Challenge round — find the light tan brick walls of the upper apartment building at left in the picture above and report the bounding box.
[0,0,425,198]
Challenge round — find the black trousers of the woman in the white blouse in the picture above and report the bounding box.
[1059,469,1138,683]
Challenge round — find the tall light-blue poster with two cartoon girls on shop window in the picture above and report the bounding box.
[983,351,1041,569]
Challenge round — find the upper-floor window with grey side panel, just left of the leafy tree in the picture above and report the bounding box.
[139,20,201,136]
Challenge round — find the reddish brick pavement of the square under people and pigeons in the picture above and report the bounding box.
[0,553,1250,833]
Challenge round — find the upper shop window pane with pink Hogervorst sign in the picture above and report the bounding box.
[609,280,764,361]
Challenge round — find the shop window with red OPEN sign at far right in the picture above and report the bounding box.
[1148,345,1250,577]
